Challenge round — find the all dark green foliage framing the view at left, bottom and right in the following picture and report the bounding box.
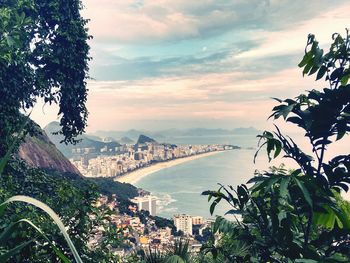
[0,0,350,263]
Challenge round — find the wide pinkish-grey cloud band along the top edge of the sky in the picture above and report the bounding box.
[83,0,345,43]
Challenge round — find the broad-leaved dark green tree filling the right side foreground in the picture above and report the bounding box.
[203,31,350,262]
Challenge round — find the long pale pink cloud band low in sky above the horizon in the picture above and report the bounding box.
[82,65,322,131]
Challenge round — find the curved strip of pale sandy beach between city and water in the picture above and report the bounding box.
[115,151,225,184]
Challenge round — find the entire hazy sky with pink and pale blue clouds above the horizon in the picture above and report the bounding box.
[32,0,350,132]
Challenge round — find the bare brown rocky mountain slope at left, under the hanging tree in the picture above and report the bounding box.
[18,124,81,176]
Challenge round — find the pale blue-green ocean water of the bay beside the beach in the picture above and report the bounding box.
[135,135,266,218]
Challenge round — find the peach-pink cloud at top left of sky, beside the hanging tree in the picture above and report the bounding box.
[83,0,198,42]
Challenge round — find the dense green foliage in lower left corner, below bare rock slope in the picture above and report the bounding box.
[0,160,128,262]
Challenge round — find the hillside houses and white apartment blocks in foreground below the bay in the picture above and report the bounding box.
[89,196,212,257]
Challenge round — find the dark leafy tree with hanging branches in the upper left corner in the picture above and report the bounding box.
[0,0,90,156]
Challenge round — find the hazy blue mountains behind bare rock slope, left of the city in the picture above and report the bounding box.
[44,122,121,158]
